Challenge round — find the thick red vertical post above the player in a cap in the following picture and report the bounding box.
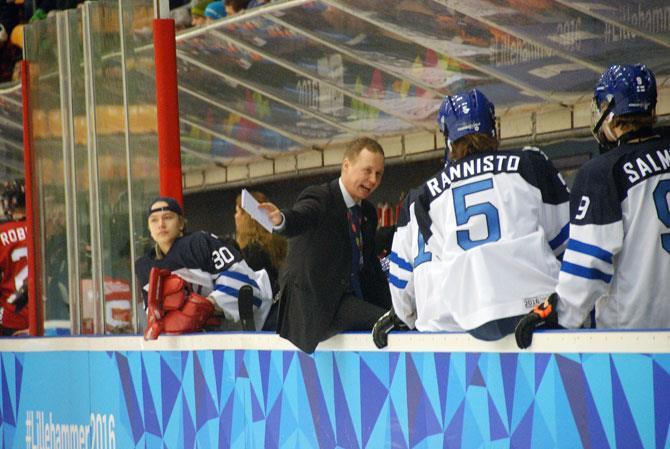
[153,19,184,206]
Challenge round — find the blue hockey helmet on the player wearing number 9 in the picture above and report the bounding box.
[593,64,657,141]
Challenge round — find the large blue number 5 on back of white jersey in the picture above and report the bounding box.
[453,179,500,251]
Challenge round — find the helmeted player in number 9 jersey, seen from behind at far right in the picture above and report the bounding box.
[517,64,670,347]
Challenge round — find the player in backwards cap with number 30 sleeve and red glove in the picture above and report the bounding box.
[135,197,272,339]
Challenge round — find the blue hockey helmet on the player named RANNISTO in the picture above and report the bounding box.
[437,89,496,148]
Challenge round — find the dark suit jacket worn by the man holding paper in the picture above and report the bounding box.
[277,179,391,353]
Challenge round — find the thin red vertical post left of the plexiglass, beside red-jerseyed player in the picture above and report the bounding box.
[21,60,44,336]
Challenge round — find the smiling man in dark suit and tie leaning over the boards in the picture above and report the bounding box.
[260,138,391,353]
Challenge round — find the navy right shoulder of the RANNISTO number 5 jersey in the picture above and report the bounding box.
[519,147,570,204]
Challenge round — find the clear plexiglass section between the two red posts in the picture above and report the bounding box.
[20,1,158,333]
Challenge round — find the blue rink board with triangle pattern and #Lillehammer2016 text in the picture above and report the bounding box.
[0,350,670,449]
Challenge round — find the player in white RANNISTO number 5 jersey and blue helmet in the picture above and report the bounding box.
[373,90,569,346]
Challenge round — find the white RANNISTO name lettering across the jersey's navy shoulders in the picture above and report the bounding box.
[426,154,521,198]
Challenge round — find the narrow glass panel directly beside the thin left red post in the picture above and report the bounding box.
[24,16,73,323]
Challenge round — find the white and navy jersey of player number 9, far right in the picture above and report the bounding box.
[557,128,670,329]
